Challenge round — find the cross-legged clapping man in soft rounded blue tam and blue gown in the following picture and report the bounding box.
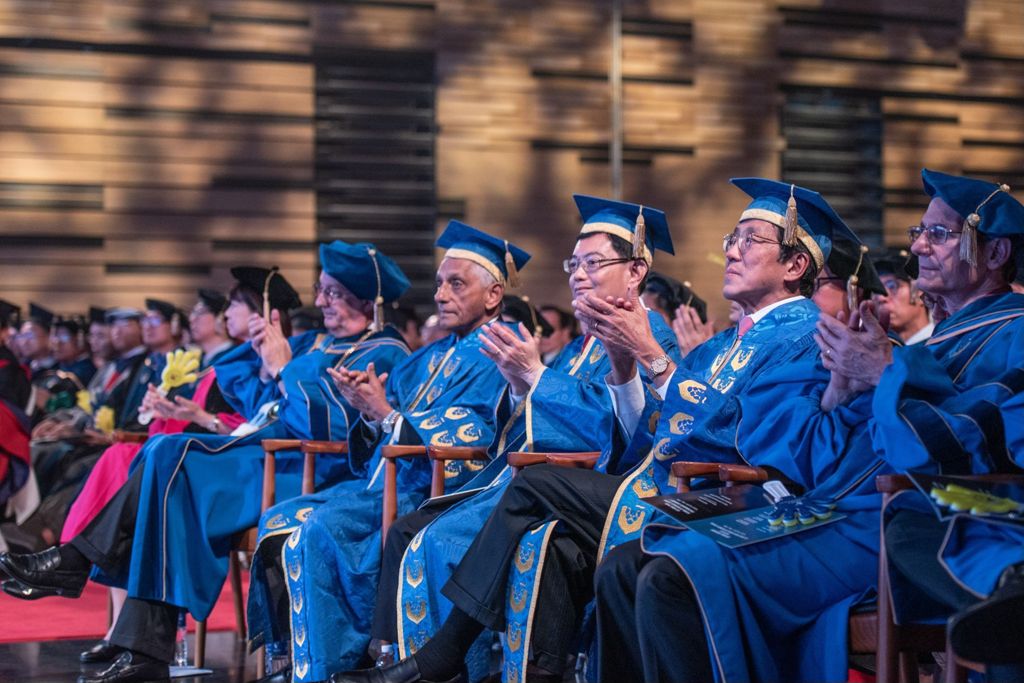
[0,242,408,683]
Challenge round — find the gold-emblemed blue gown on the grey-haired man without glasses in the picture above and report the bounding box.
[256,330,505,681]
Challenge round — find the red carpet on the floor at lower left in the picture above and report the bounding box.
[0,571,249,643]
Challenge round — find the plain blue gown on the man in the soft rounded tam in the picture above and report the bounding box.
[88,328,409,620]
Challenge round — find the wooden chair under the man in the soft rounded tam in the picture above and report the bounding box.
[196,438,348,678]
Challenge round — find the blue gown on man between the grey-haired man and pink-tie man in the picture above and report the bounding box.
[395,312,681,657]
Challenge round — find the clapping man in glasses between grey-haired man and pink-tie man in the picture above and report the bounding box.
[364,196,680,675]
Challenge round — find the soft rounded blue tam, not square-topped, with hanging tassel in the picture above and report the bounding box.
[321,240,409,303]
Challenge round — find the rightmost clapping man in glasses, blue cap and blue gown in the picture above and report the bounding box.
[596,169,1024,681]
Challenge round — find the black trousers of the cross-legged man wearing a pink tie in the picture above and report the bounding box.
[442,465,624,673]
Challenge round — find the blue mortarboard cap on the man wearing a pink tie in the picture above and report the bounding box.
[729,178,860,270]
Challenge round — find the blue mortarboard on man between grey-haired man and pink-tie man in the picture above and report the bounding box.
[572,195,676,264]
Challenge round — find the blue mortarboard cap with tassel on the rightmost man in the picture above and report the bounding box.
[921,168,1024,265]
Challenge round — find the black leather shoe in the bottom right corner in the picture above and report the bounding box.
[949,564,1024,665]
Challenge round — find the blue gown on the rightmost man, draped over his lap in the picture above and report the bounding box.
[642,298,1021,682]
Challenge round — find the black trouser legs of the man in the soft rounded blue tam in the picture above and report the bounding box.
[70,467,179,661]
